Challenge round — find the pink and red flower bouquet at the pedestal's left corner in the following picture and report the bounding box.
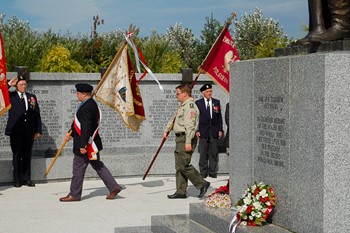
[204,180,231,209]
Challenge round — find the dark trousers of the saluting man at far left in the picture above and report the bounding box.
[10,132,34,182]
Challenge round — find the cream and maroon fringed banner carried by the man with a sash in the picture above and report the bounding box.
[95,43,145,131]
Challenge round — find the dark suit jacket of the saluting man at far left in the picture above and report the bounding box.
[5,91,42,138]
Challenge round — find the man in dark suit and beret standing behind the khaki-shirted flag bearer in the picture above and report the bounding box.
[196,84,223,178]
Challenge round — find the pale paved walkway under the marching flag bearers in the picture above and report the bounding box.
[0,175,228,233]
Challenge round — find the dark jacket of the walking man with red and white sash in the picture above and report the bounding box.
[71,98,103,155]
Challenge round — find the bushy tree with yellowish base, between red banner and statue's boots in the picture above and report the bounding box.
[234,9,288,60]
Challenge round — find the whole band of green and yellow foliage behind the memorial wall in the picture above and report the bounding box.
[0,9,287,73]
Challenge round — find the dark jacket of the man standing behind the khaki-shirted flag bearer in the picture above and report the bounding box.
[196,98,223,138]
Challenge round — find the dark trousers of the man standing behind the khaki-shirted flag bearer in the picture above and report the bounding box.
[199,136,219,177]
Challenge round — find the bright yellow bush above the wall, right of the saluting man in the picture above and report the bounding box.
[38,45,83,72]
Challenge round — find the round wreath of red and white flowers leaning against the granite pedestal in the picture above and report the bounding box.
[236,182,276,226]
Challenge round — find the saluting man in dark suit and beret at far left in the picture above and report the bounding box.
[5,76,42,188]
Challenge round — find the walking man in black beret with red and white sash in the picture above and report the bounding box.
[59,83,122,202]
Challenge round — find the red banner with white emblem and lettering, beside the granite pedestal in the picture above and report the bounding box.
[199,24,240,93]
